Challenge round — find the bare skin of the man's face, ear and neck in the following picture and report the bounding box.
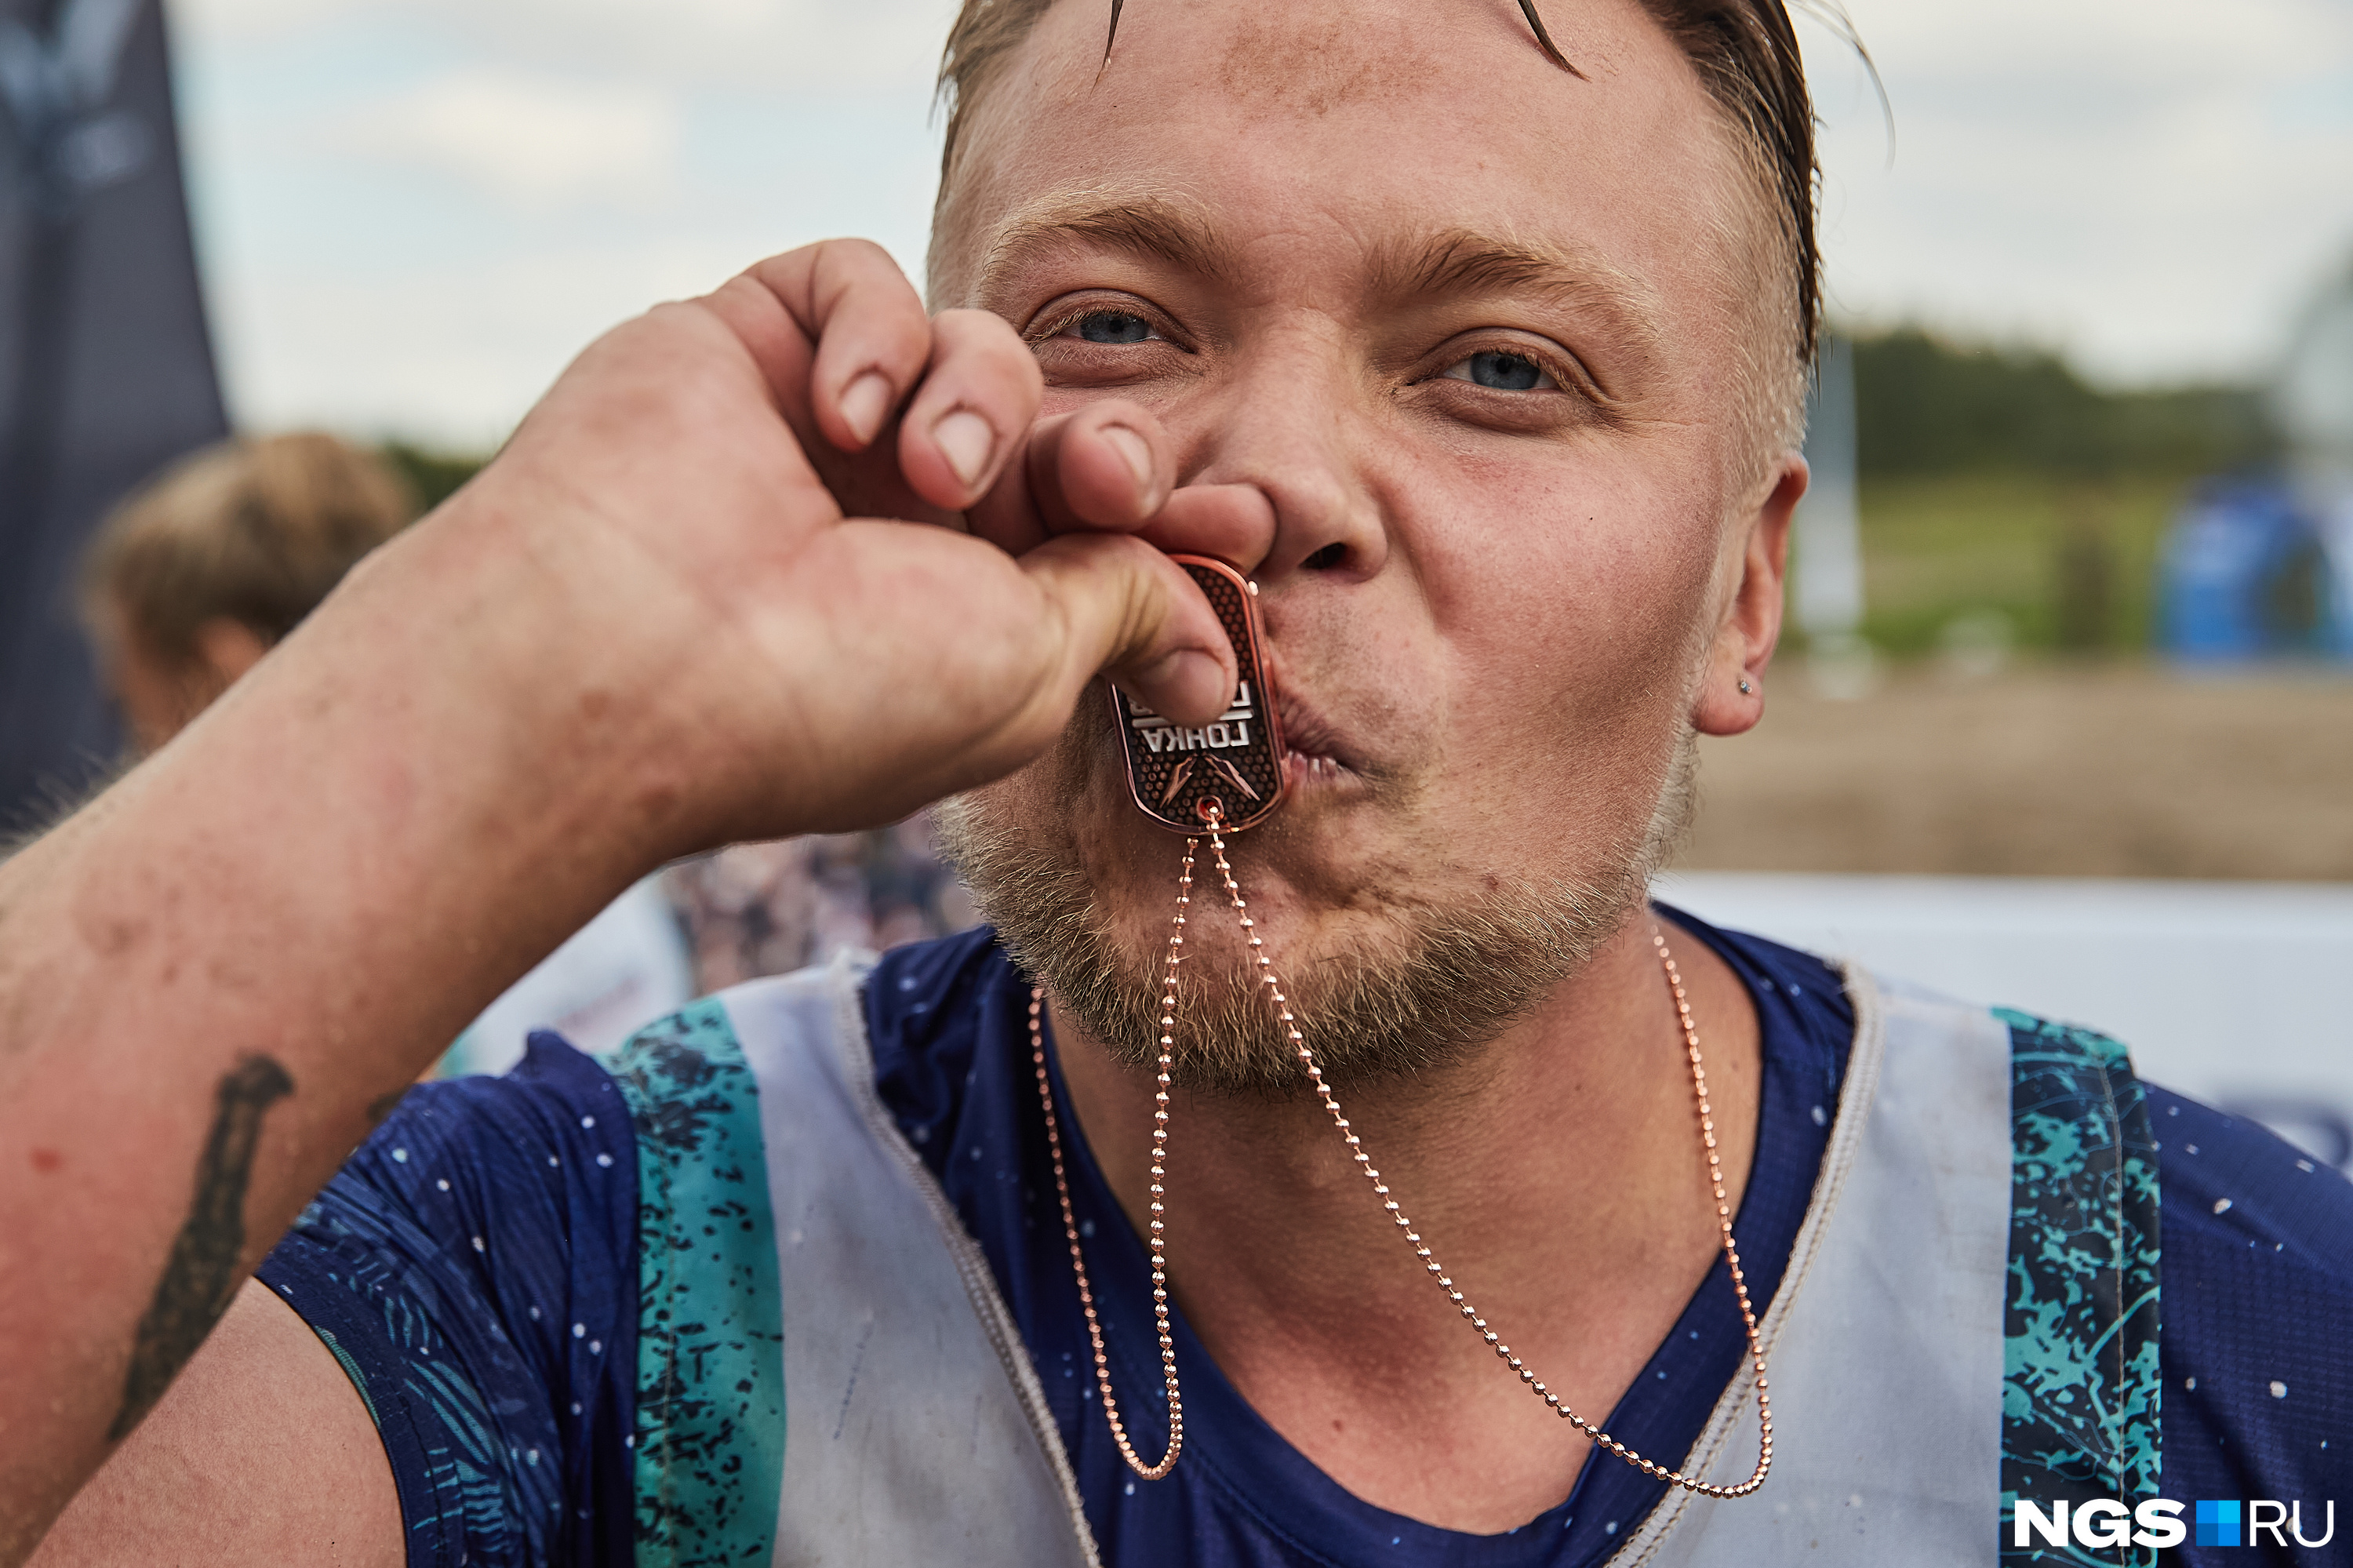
[932,0,1805,1530]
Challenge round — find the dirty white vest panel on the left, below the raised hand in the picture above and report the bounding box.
[720,961,1099,1568]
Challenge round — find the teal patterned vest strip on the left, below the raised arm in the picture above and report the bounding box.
[614,1001,784,1568]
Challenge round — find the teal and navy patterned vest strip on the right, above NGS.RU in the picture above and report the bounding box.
[1995,1010,2160,1568]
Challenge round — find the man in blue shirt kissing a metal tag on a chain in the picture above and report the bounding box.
[12,0,2353,1566]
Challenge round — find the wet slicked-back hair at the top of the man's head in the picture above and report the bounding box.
[934,0,1821,391]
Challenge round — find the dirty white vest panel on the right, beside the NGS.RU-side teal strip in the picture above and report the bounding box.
[1609,966,2009,1568]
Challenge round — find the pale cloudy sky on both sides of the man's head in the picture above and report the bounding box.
[167,0,2353,449]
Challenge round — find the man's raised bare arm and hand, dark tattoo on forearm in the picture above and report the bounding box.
[0,242,1266,1568]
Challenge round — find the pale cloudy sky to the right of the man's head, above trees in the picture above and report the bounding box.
[1807,0,2353,381]
